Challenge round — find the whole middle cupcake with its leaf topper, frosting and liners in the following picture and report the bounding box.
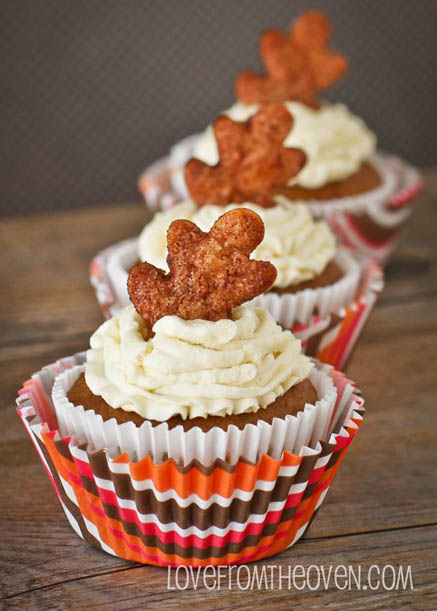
[93,104,380,367]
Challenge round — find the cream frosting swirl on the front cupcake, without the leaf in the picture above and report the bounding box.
[85,305,313,421]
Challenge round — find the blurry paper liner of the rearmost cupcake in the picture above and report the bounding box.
[138,134,423,263]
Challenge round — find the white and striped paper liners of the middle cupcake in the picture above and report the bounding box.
[90,238,383,369]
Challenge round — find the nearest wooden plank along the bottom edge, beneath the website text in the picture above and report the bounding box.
[5,527,437,610]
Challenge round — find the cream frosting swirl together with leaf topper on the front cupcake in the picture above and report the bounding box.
[85,208,313,421]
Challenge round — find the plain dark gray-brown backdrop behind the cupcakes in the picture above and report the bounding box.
[0,0,437,214]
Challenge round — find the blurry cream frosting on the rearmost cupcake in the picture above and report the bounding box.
[193,102,376,189]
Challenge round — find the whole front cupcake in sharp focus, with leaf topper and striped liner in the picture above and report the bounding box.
[18,209,363,566]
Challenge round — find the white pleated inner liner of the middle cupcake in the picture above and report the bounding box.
[105,239,363,329]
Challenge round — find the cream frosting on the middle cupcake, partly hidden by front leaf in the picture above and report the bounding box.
[138,196,336,288]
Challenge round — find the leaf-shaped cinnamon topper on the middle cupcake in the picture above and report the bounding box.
[185,103,306,207]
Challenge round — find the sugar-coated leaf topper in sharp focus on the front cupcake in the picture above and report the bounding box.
[128,208,277,333]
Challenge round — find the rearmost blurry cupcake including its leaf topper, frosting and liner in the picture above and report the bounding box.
[139,11,422,262]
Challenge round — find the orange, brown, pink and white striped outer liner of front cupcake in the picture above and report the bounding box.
[18,353,364,567]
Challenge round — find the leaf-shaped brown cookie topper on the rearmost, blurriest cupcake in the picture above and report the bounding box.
[235,11,347,108]
